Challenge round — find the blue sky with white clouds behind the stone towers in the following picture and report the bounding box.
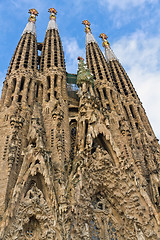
[0,0,160,138]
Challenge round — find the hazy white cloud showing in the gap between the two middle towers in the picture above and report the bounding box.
[62,38,85,73]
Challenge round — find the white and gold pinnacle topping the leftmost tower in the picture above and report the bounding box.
[22,8,38,37]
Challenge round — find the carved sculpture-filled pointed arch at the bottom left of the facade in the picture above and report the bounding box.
[3,185,62,240]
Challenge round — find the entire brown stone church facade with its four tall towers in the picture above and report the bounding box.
[0,8,160,240]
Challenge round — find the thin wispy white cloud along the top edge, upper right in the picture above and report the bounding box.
[100,0,158,10]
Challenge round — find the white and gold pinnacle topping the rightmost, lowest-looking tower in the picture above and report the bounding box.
[99,33,118,62]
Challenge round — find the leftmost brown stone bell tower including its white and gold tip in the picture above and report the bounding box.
[0,9,38,218]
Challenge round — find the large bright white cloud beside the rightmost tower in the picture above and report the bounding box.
[113,31,160,138]
